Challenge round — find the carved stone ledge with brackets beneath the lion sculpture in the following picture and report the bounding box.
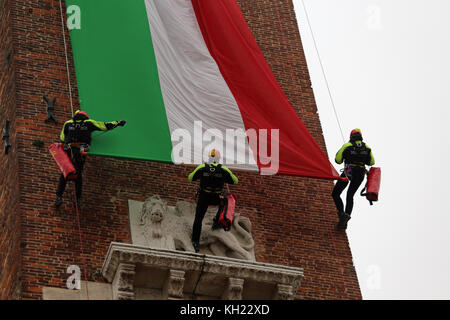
[102,242,303,299]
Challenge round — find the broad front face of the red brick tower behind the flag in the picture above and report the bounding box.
[7,0,361,299]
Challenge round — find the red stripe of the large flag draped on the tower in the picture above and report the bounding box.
[192,0,339,180]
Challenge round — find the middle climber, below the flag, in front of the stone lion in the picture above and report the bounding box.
[188,149,238,252]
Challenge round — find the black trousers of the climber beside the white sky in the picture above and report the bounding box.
[331,167,366,214]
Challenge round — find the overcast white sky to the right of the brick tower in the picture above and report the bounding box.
[293,0,450,299]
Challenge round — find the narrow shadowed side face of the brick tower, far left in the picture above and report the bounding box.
[0,1,20,299]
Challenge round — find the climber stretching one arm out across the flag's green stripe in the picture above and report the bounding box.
[55,110,126,207]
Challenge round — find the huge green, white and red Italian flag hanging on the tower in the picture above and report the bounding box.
[66,0,338,179]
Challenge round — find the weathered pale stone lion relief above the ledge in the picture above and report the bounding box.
[130,195,255,261]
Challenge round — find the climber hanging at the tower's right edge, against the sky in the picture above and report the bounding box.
[332,129,375,230]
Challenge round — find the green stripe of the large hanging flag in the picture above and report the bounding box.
[66,0,172,162]
